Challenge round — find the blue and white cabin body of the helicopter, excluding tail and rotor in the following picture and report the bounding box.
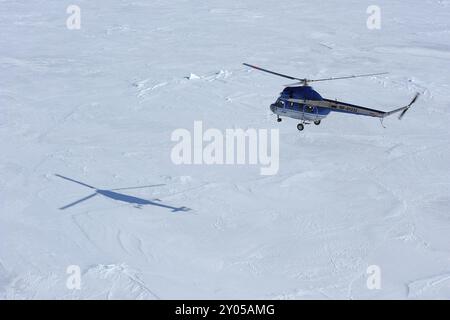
[270,86,330,122]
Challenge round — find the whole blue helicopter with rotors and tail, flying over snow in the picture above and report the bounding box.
[244,63,420,131]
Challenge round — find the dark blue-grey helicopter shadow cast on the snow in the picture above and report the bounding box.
[55,174,191,212]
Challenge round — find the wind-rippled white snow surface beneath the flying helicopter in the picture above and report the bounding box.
[0,0,450,299]
